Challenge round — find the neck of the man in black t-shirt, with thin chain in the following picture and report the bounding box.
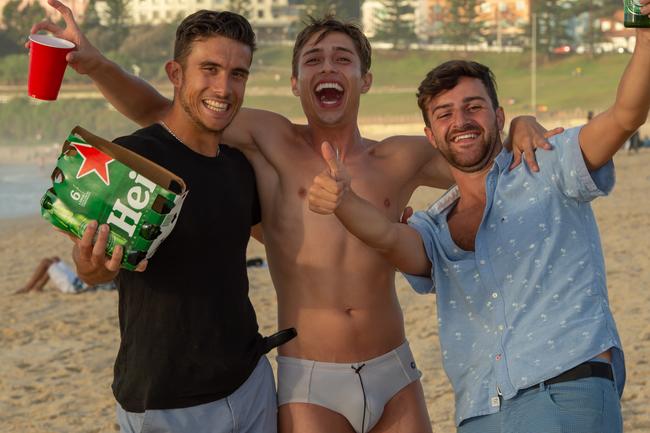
[161,104,221,157]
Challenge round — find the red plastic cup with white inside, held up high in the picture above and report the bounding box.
[27,35,75,101]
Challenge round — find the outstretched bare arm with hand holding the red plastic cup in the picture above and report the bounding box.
[31,0,172,126]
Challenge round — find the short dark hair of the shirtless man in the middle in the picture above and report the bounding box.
[291,15,372,77]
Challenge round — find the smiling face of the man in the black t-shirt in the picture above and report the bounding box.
[168,36,252,133]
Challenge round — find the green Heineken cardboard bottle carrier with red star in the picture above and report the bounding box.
[41,126,188,270]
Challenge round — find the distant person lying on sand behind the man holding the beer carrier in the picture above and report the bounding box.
[15,256,115,295]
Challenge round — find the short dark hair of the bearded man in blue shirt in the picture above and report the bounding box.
[416,60,499,126]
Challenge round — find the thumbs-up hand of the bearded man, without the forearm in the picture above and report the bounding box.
[309,141,351,215]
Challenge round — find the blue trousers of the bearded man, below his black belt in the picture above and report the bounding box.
[457,377,623,433]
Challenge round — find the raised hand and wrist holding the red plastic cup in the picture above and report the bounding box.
[25,0,104,74]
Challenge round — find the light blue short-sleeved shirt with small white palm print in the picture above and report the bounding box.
[406,128,625,424]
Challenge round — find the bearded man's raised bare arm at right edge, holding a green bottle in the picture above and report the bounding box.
[579,25,650,171]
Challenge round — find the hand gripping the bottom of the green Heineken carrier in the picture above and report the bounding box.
[72,221,123,285]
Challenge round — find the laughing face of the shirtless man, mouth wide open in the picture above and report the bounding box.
[291,32,372,126]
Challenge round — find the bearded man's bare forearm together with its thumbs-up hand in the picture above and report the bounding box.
[309,142,431,276]
